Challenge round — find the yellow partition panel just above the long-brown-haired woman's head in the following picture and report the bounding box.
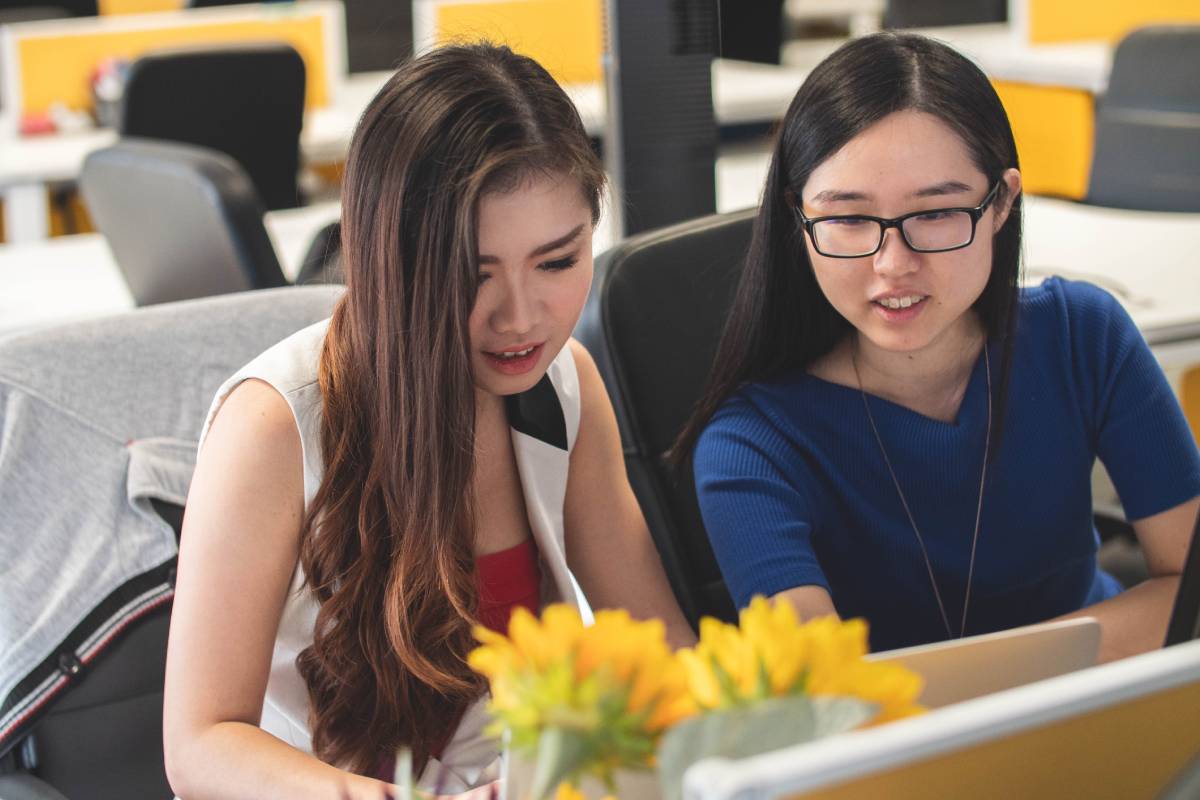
[433,0,604,83]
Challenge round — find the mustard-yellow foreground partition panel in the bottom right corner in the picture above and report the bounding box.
[796,682,1200,800]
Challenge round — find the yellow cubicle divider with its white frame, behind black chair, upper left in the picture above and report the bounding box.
[6,2,343,114]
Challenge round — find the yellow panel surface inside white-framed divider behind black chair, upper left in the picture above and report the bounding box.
[16,8,330,114]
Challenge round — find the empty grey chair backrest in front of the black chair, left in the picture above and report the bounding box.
[79,139,287,306]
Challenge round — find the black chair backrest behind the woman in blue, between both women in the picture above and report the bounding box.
[576,209,755,624]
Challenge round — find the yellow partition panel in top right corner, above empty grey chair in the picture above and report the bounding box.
[1026,0,1200,44]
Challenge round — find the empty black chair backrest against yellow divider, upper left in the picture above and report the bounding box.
[119,42,305,211]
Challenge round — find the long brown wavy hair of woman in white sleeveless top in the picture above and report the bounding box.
[296,44,605,774]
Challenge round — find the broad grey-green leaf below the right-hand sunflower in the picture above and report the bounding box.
[659,696,877,800]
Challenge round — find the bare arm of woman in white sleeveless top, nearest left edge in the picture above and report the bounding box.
[163,380,388,800]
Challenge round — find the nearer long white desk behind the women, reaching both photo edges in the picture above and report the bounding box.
[0,148,1200,368]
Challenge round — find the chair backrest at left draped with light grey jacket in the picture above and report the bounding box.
[0,287,341,800]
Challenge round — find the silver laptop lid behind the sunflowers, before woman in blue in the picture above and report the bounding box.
[866,616,1100,709]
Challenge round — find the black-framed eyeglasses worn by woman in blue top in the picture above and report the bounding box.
[796,181,1000,258]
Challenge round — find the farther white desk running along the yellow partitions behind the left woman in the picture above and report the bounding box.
[0,59,808,243]
